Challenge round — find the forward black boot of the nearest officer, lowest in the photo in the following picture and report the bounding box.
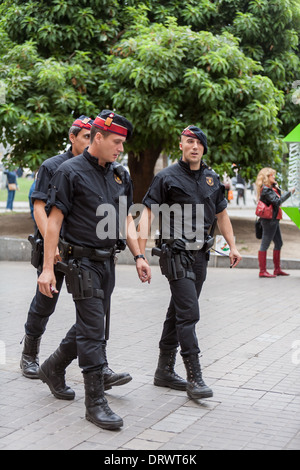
[83,370,123,429]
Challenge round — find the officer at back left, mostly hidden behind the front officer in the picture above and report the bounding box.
[20,115,131,389]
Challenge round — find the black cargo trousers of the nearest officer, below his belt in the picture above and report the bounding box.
[60,256,115,372]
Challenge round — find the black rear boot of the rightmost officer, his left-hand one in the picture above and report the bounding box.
[154,349,187,390]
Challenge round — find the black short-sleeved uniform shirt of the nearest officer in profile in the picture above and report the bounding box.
[47,149,133,248]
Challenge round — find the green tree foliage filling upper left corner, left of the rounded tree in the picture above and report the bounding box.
[0,0,119,170]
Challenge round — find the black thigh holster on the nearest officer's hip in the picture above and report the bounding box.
[56,259,104,300]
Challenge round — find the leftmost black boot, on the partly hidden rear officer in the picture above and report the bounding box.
[20,335,42,379]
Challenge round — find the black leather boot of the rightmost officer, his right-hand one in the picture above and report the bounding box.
[183,354,213,400]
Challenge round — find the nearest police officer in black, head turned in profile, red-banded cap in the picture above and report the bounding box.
[38,110,151,429]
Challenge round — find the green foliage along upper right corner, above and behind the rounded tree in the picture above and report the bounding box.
[142,0,300,136]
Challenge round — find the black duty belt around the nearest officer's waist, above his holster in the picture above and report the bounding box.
[59,239,117,261]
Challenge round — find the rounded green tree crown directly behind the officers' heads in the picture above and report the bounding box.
[99,9,283,198]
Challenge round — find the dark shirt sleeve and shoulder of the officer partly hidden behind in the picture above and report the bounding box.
[31,149,73,203]
